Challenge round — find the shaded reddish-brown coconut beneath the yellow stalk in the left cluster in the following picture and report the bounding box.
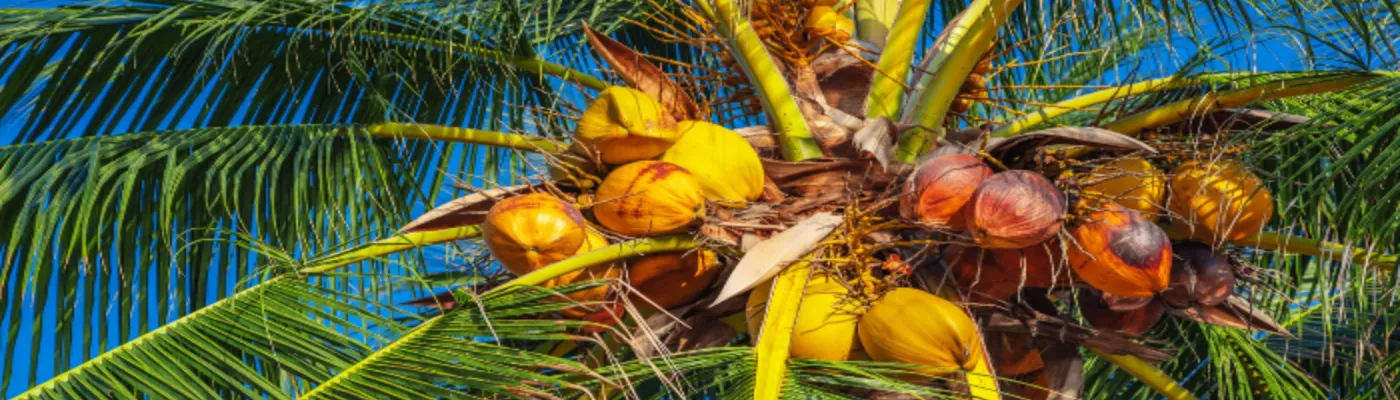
[627,250,722,310]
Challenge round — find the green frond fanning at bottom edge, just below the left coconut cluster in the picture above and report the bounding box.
[305,281,608,399]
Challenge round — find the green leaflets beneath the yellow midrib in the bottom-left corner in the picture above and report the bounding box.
[18,278,403,399]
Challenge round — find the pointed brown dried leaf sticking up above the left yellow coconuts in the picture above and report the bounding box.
[584,24,700,120]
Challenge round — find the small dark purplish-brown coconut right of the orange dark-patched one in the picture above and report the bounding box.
[1162,242,1235,308]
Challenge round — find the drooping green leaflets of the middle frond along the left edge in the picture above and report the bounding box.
[0,124,431,388]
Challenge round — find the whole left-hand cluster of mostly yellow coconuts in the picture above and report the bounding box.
[482,87,763,322]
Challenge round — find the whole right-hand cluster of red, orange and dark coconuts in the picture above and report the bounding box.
[900,154,1273,336]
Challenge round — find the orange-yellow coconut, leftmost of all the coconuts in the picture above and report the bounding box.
[482,193,587,274]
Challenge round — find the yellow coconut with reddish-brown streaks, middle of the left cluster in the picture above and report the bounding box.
[594,161,704,236]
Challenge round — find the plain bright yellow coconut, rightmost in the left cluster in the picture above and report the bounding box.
[661,120,763,206]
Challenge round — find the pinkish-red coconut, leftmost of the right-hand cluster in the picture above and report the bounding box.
[899,154,991,229]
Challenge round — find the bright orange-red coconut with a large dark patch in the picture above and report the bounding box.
[1068,203,1172,298]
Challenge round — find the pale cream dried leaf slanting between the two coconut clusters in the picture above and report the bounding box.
[708,213,844,306]
